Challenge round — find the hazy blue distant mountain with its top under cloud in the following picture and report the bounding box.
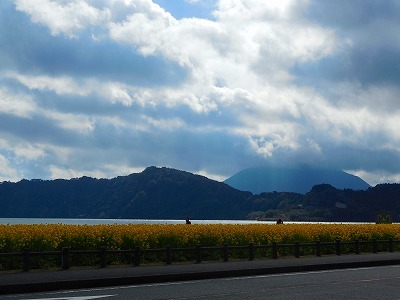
[224,167,370,194]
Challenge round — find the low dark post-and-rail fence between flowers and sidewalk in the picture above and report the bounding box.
[0,238,400,271]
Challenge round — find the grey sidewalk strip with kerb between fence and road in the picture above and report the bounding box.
[0,252,400,300]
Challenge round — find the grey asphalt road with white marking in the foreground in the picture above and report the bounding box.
[0,266,400,300]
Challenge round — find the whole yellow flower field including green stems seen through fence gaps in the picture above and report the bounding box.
[0,224,400,271]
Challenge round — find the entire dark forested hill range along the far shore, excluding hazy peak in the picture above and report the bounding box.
[0,167,400,222]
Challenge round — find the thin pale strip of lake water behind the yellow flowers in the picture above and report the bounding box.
[0,218,366,225]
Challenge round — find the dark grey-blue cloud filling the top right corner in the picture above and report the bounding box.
[292,0,400,86]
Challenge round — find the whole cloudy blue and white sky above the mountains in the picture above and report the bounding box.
[0,0,400,185]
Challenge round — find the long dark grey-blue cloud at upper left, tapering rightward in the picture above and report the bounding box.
[0,1,186,86]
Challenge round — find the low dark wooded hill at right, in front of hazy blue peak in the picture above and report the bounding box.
[248,184,400,222]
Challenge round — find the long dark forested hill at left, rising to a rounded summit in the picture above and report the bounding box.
[0,167,251,219]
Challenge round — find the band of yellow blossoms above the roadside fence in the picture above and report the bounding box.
[0,224,400,253]
